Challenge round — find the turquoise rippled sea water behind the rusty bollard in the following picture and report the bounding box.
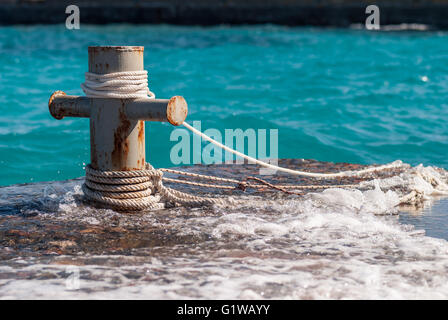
[0,25,448,185]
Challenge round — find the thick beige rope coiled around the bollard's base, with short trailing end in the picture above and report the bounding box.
[82,163,232,211]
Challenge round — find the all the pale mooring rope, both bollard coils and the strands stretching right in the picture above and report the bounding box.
[81,71,412,210]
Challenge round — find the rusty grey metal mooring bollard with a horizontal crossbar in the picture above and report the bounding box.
[48,46,188,171]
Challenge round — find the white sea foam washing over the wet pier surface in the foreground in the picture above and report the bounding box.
[0,166,448,299]
